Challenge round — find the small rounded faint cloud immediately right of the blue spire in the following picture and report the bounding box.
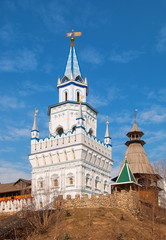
[80,47,103,65]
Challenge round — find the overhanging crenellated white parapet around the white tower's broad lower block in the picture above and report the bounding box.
[29,129,112,171]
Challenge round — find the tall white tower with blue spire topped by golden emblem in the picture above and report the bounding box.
[29,32,113,208]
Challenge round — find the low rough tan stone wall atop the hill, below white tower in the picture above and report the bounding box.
[54,190,140,215]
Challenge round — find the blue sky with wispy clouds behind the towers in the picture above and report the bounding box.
[0,0,166,182]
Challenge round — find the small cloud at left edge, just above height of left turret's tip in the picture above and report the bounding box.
[0,96,25,110]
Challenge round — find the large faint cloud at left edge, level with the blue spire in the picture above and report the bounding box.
[0,49,38,72]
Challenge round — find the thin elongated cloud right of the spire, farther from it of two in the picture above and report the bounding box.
[109,50,143,63]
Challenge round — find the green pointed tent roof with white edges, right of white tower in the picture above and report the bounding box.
[116,160,137,183]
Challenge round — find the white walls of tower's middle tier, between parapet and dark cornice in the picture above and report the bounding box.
[49,103,97,136]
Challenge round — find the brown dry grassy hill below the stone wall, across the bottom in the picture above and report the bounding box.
[0,208,166,240]
